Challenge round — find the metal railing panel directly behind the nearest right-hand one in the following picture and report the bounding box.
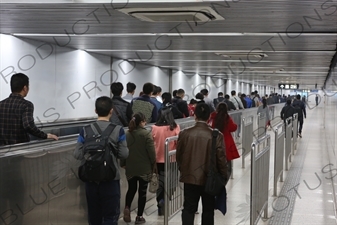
[274,121,285,196]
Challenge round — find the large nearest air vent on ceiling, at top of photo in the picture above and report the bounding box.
[119,7,224,23]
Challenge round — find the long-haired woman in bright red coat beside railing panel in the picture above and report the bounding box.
[209,102,240,177]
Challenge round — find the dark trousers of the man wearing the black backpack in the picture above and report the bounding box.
[85,180,121,225]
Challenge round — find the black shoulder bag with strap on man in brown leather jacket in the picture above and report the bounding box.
[205,129,226,196]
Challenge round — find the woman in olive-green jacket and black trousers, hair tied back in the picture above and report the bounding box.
[121,112,156,224]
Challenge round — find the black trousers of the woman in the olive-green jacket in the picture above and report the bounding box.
[125,177,148,216]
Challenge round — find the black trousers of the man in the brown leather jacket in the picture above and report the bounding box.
[181,183,215,225]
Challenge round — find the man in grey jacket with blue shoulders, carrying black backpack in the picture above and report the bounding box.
[74,96,129,225]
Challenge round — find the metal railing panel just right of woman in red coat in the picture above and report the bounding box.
[241,116,254,168]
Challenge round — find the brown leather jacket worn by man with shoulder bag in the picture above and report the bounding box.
[177,122,228,186]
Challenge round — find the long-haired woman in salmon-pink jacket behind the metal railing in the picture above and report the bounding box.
[152,107,180,215]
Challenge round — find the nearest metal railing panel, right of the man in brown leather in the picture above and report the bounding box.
[250,134,270,225]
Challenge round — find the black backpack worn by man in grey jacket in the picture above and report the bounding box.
[78,123,117,182]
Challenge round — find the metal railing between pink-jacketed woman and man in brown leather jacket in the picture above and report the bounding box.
[164,136,184,225]
